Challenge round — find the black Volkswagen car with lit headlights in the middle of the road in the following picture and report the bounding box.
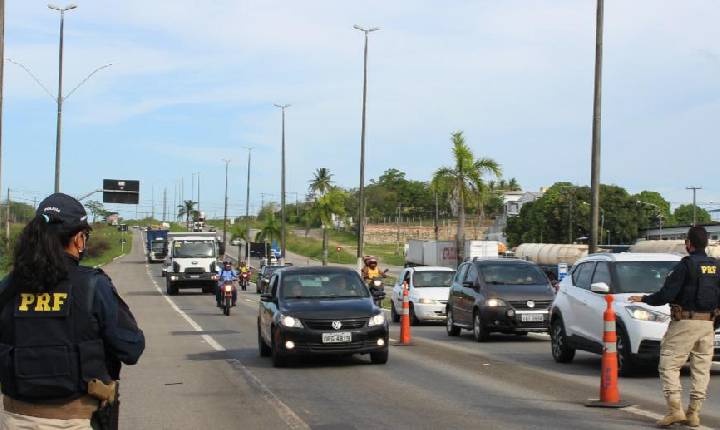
[257,267,389,367]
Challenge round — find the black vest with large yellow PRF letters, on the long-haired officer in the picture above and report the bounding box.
[0,271,110,403]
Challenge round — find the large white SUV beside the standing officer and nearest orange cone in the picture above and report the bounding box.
[550,252,681,376]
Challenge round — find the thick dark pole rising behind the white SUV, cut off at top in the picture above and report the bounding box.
[588,0,605,254]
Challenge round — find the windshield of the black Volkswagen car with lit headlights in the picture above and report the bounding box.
[281,272,370,299]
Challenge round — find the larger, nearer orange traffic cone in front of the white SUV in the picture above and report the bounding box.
[585,294,630,408]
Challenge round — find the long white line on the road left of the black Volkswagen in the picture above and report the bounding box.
[145,264,310,430]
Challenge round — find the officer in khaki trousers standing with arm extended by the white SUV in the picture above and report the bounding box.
[629,226,720,427]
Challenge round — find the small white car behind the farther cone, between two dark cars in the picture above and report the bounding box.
[390,266,455,325]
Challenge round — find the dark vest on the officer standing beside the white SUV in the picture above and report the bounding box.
[681,255,720,312]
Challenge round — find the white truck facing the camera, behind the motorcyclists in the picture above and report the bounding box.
[163,232,225,295]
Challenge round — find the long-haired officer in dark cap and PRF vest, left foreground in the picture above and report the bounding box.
[0,193,145,430]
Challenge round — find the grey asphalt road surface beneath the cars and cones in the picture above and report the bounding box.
[106,235,720,430]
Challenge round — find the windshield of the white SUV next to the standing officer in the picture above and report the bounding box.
[615,261,678,293]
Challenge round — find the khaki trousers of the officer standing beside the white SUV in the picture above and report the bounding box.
[659,320,715,400]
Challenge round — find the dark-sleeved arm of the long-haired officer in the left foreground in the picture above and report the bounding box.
[94,275,145,364]
